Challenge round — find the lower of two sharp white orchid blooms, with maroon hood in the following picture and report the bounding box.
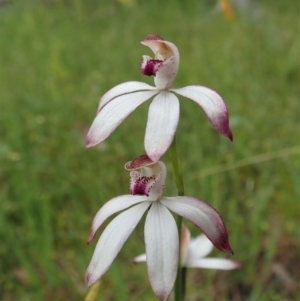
[86,155,233,300]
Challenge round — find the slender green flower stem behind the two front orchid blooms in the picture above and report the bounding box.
[169,136,186,301]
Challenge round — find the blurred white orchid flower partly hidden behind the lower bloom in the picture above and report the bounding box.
[133,225,241,270]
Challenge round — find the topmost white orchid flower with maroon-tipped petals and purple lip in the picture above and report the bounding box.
[86,34,232,162]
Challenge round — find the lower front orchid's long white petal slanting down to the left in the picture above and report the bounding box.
[85,202,150,286]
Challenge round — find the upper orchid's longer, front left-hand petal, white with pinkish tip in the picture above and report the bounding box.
[86,91,157,147]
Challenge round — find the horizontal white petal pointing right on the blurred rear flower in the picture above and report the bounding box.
[185,258,241,270]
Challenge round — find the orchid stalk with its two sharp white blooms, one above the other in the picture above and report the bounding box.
[86,35,233,301]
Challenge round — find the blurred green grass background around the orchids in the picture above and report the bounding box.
[0,0,300,301]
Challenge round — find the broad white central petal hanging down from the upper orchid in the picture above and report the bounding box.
[145,91,179,161]
